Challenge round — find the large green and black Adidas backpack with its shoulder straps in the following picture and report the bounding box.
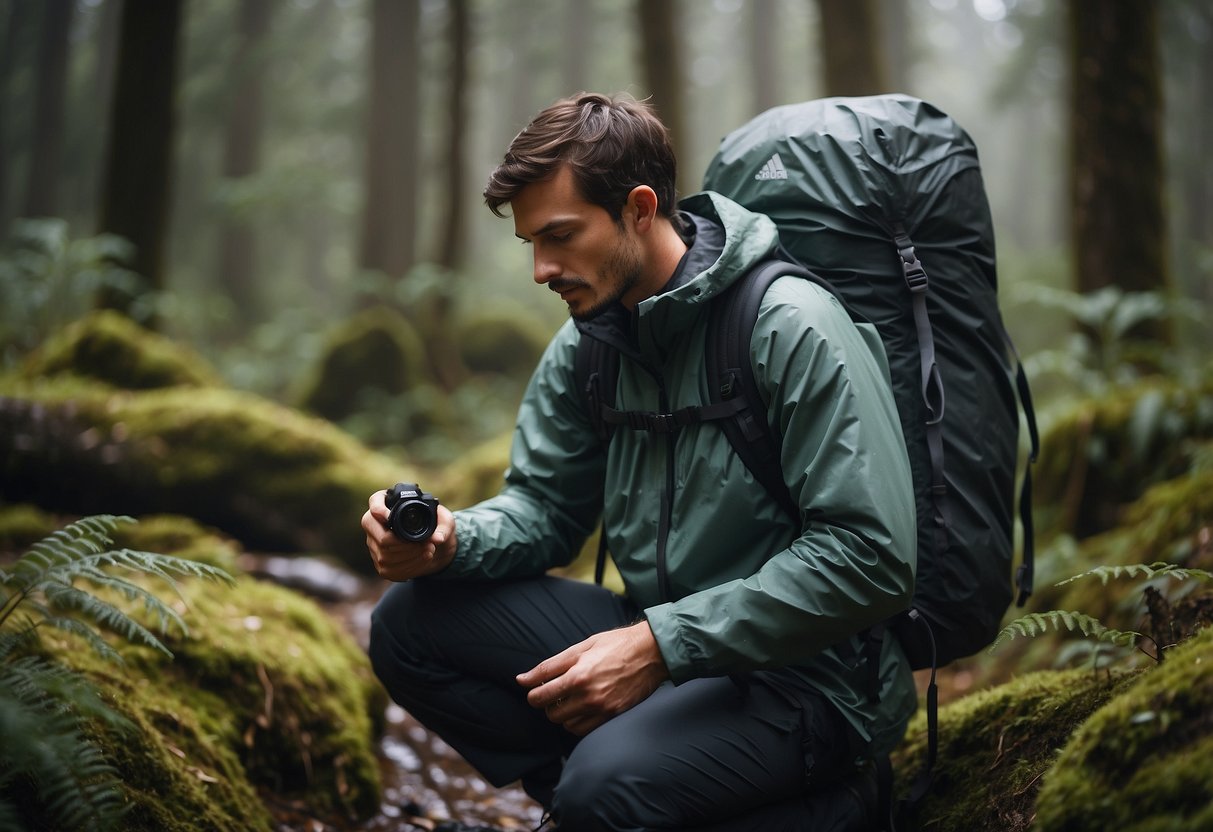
[576,95,1038,674]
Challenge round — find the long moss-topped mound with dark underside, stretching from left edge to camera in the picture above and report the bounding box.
[0,380,403,574]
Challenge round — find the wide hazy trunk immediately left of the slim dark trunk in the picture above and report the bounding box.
[359,0,421,288]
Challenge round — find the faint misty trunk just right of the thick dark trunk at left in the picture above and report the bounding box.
[218,0,273,323]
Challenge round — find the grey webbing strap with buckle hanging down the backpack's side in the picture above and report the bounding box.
[893,222,951,553]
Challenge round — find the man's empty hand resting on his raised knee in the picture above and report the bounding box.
[518,621,670,736]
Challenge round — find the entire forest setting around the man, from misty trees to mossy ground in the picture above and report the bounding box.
[0,0,1213,832]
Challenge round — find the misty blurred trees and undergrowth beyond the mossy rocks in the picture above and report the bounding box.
[0,0,1213,470]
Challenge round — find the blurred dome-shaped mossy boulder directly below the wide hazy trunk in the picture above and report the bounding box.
[298,307,426,421]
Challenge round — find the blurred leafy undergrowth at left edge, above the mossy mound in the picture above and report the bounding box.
[0,218,154,366]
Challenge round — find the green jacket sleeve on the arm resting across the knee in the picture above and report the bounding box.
[645,279,916,682]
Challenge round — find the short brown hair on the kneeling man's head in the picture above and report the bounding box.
[484,92,676,222]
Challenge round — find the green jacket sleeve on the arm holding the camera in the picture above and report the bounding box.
[440,321,605,579]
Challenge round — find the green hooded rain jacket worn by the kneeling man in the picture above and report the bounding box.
[443,193,917,752]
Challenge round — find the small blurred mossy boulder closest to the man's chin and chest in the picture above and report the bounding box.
[456,302,552,380]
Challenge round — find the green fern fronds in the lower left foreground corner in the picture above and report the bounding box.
[0,515,232,830]
